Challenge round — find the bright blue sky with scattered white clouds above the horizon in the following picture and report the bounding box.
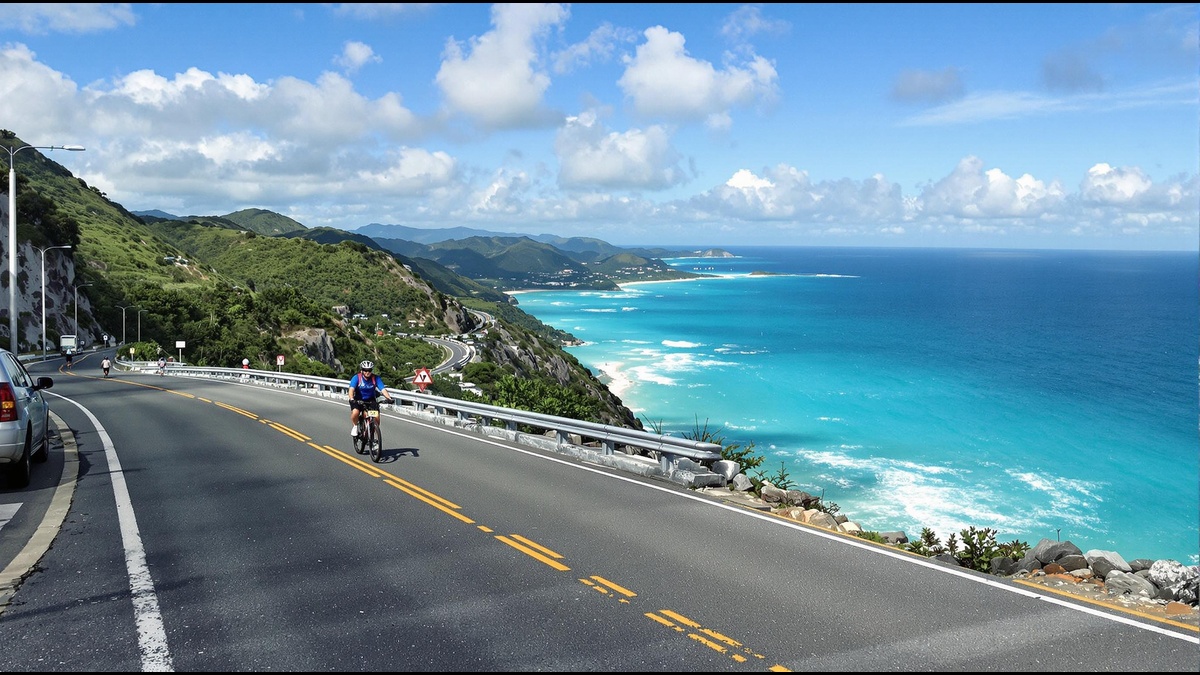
[0,4,1200,250]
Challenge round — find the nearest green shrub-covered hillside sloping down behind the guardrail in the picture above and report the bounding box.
[0,131,641,429]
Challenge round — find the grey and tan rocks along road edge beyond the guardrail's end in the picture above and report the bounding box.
[702,470,1200,626]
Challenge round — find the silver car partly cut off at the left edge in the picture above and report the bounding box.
[0,350,54,489]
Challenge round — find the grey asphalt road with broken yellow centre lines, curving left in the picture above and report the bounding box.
[0,354,1200,673]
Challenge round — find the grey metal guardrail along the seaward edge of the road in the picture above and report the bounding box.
[121,360,726,488]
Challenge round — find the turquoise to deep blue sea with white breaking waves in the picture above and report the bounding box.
[516,247,1200,565]
